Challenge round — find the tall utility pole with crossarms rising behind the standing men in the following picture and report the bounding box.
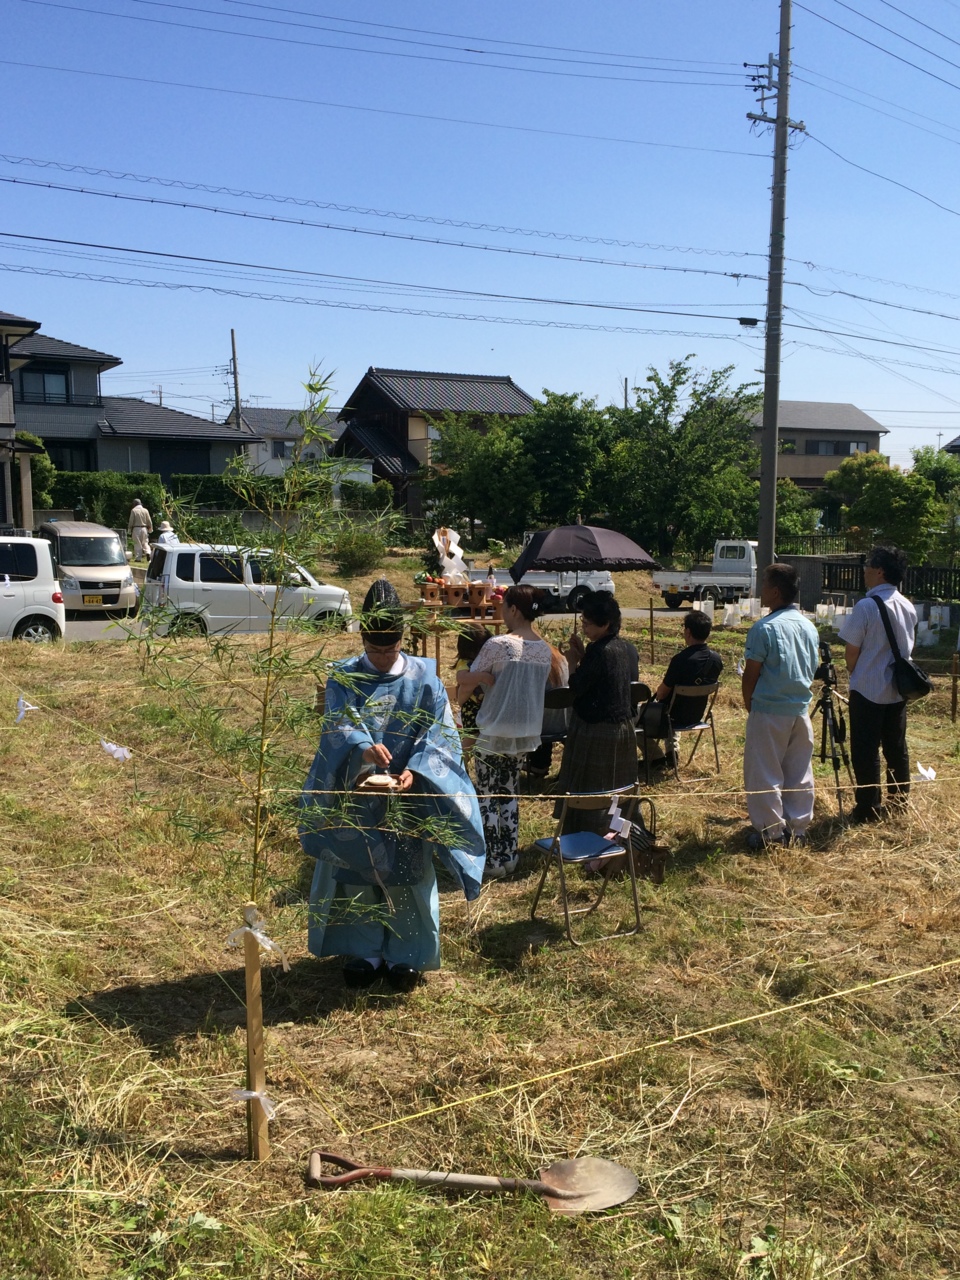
[748,0,804,567]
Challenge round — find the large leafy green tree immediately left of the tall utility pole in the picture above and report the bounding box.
[603,356,760,558]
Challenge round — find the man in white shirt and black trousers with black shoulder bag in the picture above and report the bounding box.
[840,547,929,826]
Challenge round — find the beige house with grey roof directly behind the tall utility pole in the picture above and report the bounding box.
[754,401,887,489]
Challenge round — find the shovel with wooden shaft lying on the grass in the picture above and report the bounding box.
[307,1151,640,1213]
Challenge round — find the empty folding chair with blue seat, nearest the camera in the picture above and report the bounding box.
[530,783,655,947]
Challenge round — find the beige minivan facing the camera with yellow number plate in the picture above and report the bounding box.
[37,520,138,613]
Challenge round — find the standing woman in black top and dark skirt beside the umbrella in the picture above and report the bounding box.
[557,591,640,835]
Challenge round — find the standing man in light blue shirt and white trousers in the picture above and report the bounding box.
[741,564,819,849]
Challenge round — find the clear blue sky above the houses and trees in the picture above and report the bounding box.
[0,0,960,463]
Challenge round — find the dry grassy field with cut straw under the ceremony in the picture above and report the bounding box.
[0,593,960,1280]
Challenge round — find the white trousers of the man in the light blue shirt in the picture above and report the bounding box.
[744,712,813,840]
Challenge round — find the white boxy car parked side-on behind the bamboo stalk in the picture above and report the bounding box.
[143,543,352,635]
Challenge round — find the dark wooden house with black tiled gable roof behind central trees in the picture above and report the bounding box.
[335,365,535,516]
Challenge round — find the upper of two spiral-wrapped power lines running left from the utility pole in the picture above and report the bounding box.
[0,154,765,259]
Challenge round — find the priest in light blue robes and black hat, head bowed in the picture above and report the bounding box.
[301,579,485,991]
